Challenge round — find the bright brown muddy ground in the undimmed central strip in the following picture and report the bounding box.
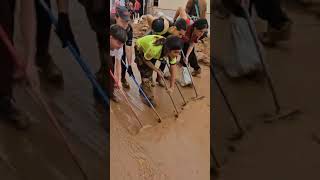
[110,16,210,180]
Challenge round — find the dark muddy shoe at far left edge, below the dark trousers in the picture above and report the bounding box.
[0,97,30,130]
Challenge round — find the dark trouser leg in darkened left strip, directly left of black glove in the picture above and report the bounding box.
[35,0,51,56]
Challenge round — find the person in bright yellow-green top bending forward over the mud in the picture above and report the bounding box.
[135,35,183,106]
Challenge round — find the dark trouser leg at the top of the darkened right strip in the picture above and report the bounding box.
[252,0,289,29]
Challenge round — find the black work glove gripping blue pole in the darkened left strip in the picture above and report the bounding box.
[56,13,80,54]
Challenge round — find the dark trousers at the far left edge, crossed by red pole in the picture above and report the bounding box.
[0,0,15,98]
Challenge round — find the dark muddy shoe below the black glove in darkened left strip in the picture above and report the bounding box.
[36,54,63,83]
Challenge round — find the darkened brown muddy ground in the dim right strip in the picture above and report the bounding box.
[211,1,320,180]
